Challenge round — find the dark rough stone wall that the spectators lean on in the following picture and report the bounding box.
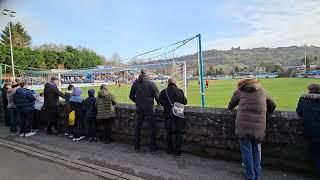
[54,104,311,171]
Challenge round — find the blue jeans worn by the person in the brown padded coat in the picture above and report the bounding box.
[240,138,261,180]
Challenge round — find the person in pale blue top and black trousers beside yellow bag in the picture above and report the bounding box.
[70,87,86,141]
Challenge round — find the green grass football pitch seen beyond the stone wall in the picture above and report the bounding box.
[60,78,320,111]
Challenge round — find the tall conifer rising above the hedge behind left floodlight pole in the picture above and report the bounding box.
[0,22,31,47]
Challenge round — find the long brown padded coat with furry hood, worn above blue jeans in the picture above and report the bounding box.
[228,79,276,141]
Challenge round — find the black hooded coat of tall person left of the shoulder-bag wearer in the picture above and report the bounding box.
[129,75,159,114]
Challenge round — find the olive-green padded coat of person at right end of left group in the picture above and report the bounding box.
[96,90,117,119]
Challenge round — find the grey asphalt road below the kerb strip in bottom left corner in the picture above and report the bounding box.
[0,146,102,180]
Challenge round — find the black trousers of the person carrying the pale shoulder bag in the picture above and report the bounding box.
[166,115,184,155]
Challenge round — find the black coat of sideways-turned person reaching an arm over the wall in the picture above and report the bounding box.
[44,82,65,111]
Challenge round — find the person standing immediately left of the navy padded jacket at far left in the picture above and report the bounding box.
[7,82,20,134]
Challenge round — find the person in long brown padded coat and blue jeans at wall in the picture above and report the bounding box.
[228,76,276,180]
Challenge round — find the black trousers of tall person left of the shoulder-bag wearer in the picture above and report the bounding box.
[135,113,157,150]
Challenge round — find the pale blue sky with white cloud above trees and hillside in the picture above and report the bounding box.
[0,0,320,58]
